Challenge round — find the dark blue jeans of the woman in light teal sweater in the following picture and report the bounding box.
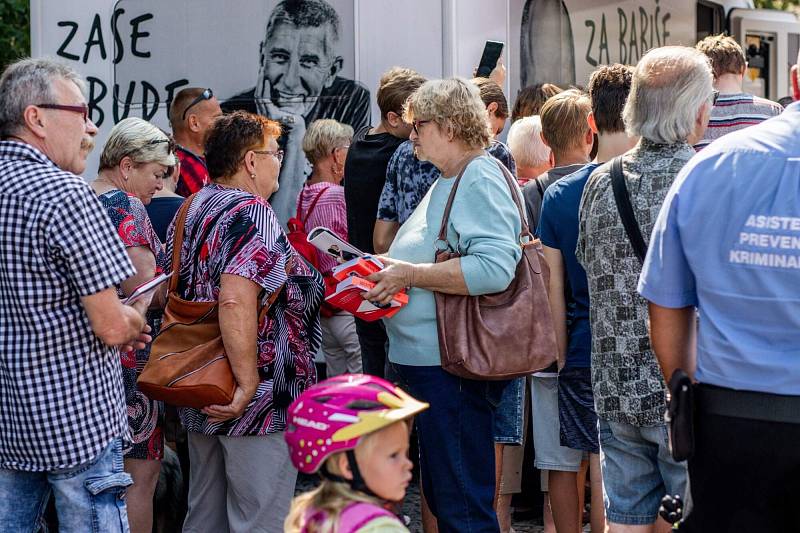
[392,364,508,533]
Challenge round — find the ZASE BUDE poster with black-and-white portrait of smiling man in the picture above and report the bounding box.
[32,0,371,222]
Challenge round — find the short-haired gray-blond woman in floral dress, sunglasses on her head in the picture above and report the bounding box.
[92,118,177,533]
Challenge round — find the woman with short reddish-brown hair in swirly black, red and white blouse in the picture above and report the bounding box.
[167,111,323,532]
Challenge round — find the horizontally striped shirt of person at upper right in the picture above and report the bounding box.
[694,93,783,152]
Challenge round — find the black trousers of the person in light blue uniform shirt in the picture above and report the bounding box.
[679,409,800,533]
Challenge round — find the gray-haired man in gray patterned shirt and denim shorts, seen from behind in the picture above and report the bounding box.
[576,46,714,533]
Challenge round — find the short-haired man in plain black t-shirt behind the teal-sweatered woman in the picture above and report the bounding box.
[344,67,426,377]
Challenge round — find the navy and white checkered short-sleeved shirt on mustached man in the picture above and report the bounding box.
[0,141,135,470]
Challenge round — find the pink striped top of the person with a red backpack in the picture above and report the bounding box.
[297,181,347,275]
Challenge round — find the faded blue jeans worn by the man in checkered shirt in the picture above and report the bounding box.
[0,438,133,533]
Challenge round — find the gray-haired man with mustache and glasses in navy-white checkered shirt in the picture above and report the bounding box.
[0,59,149,532]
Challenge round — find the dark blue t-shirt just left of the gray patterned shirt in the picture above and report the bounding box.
[536,163,598,368]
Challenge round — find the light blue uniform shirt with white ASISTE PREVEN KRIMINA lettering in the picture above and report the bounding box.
[639,103,800,395]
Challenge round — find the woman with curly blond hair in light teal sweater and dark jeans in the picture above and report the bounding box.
[365,78,526,533]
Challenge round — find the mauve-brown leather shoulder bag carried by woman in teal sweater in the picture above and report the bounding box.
[434,156,558,380]
